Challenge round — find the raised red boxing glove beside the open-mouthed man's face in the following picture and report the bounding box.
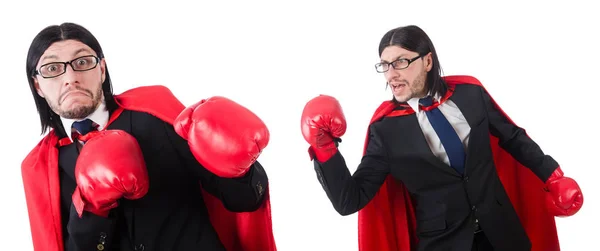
[301,95,346,162]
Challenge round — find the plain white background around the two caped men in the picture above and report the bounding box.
[0,1,600,251]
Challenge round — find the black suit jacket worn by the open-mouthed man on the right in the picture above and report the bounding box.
[314,84,558,251]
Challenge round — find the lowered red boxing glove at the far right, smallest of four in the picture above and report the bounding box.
[546,167,583,217]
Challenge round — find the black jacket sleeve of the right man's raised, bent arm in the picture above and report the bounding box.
[313,125,390,215]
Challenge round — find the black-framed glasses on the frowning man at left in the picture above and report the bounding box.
[34,55,100,78]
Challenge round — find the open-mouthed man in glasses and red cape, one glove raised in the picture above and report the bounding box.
[302,26,583,251]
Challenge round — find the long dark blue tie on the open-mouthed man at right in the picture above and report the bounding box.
[419,96,465,174]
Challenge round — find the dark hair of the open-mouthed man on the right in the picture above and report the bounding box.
[379,25,448,99]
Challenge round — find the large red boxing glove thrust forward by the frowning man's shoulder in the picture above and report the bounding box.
[173,96,270,178]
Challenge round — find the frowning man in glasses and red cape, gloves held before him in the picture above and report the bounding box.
[22,23,275,251]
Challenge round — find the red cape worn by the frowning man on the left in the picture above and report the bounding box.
[21,86,277,251]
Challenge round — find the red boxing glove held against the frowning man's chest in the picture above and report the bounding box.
[72,130,149,217]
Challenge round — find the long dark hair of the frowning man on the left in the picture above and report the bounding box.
[26,23,117,134]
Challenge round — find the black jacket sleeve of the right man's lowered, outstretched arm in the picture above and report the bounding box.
[481,88,558,182]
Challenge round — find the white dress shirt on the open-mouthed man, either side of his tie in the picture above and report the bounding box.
[407,96,471,165]
